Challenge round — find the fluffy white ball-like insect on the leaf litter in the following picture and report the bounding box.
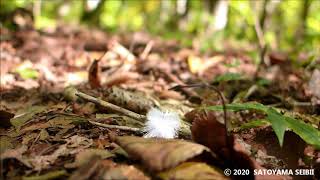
[144,108,180,139]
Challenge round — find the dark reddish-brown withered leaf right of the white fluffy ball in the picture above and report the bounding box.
[186,110,255,179]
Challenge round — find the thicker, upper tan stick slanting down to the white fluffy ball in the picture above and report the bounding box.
[75,92,146,122]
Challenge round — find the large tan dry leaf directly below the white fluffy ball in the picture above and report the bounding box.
[115,136,210,171]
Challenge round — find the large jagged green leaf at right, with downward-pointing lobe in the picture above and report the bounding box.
[206,102,320,149]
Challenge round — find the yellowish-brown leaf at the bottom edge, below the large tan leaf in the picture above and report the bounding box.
[158,162,229,180]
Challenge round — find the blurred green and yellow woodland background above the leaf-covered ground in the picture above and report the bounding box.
[0,0,320,57]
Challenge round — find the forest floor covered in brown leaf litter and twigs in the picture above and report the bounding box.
[0,26,320,179]
